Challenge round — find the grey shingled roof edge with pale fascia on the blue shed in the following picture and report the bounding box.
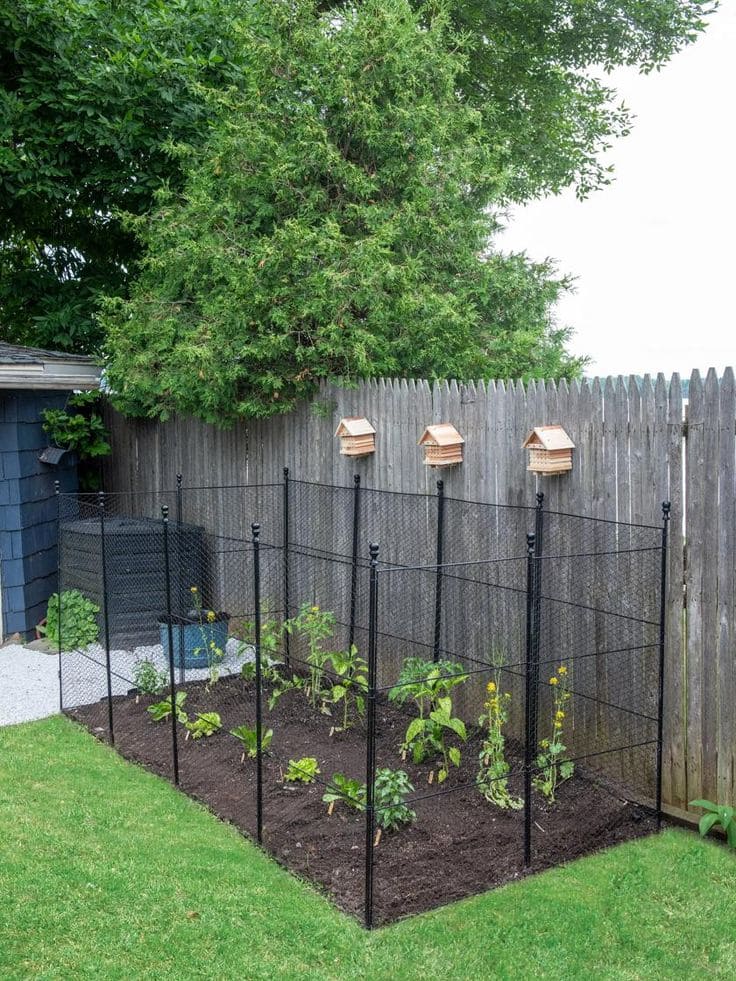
[0,341,102,391]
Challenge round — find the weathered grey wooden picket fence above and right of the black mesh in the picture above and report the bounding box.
[105,368,736,809]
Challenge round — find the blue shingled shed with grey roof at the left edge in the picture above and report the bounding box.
[0,341,100,641]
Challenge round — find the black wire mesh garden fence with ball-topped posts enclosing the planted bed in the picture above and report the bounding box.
[58,470,669,928]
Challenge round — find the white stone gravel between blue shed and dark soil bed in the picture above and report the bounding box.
[0,637,254,725]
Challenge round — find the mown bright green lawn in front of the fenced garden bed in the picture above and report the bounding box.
[0,718,736,981]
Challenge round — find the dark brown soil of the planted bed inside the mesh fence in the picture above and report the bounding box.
[68,678,656,923]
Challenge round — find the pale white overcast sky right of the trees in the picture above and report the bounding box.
[498,0,736,375]
